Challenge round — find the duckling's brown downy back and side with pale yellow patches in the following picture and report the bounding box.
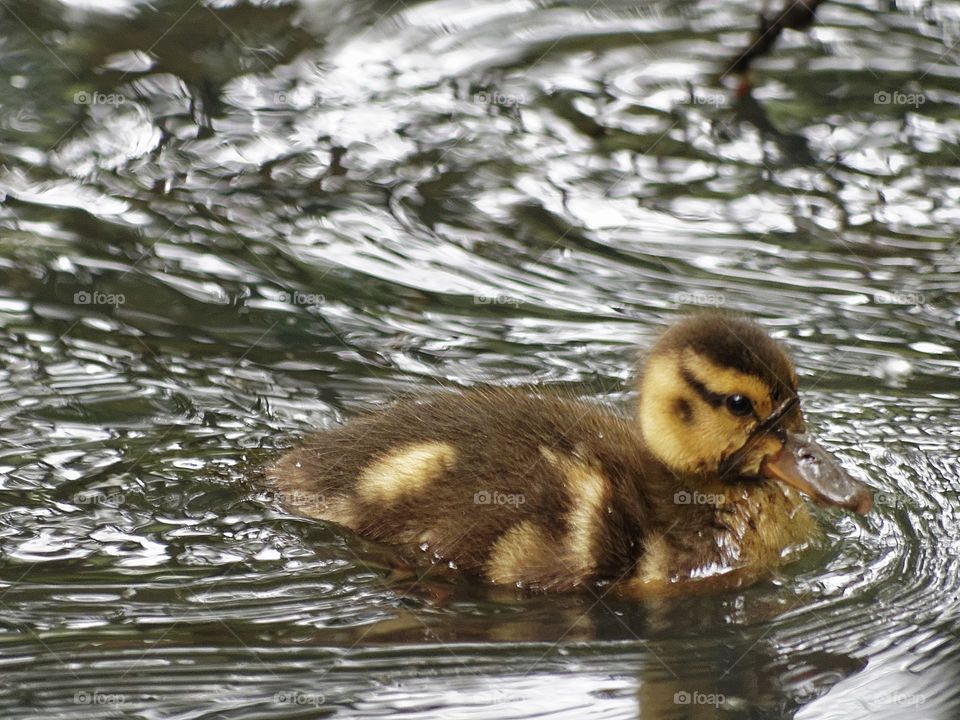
[269,388,670,590]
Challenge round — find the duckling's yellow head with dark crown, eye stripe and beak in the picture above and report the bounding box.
[638,312,872,512]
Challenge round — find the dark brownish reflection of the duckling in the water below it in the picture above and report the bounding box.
[304,571,866,719]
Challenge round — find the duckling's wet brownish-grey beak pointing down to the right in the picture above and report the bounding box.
[760,433,873,514]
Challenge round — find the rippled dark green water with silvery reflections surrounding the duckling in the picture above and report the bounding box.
[0,0,960,719]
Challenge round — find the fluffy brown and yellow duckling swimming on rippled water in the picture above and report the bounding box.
[267,312,872,598]
